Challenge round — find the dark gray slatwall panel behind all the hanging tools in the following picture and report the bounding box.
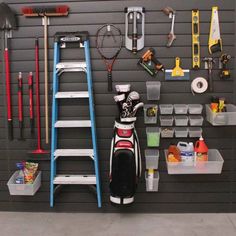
[0,0,236,213]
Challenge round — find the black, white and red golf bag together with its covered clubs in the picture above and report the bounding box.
[110,85,143,205]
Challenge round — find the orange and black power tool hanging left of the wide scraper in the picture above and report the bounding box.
[138,48,165,76]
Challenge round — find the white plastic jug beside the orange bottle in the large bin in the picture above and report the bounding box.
[177,142,194,165]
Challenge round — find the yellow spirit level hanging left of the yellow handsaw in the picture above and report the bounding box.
[192,10,201,69]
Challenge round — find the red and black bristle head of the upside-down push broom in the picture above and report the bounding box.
[22,5,69,16]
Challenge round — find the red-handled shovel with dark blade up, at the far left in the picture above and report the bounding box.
[0,3,16,140]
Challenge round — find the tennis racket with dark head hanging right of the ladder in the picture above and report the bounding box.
[96,24,123,91]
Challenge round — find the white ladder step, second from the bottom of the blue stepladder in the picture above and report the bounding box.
[54,149,94,159]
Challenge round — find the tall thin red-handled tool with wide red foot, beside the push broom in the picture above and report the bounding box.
[32,39,49,154]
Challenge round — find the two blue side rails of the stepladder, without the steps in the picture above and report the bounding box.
[50,32,102,208]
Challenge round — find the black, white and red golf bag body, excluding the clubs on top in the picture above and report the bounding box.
[110,121,141,205]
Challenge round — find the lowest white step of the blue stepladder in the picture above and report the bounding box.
[53,175,96,185]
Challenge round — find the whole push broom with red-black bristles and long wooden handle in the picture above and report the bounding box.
[22,5,69,143]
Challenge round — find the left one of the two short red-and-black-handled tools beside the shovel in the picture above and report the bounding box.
[18,72,23,139]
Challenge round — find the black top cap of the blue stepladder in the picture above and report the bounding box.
[54,31,89,43]
